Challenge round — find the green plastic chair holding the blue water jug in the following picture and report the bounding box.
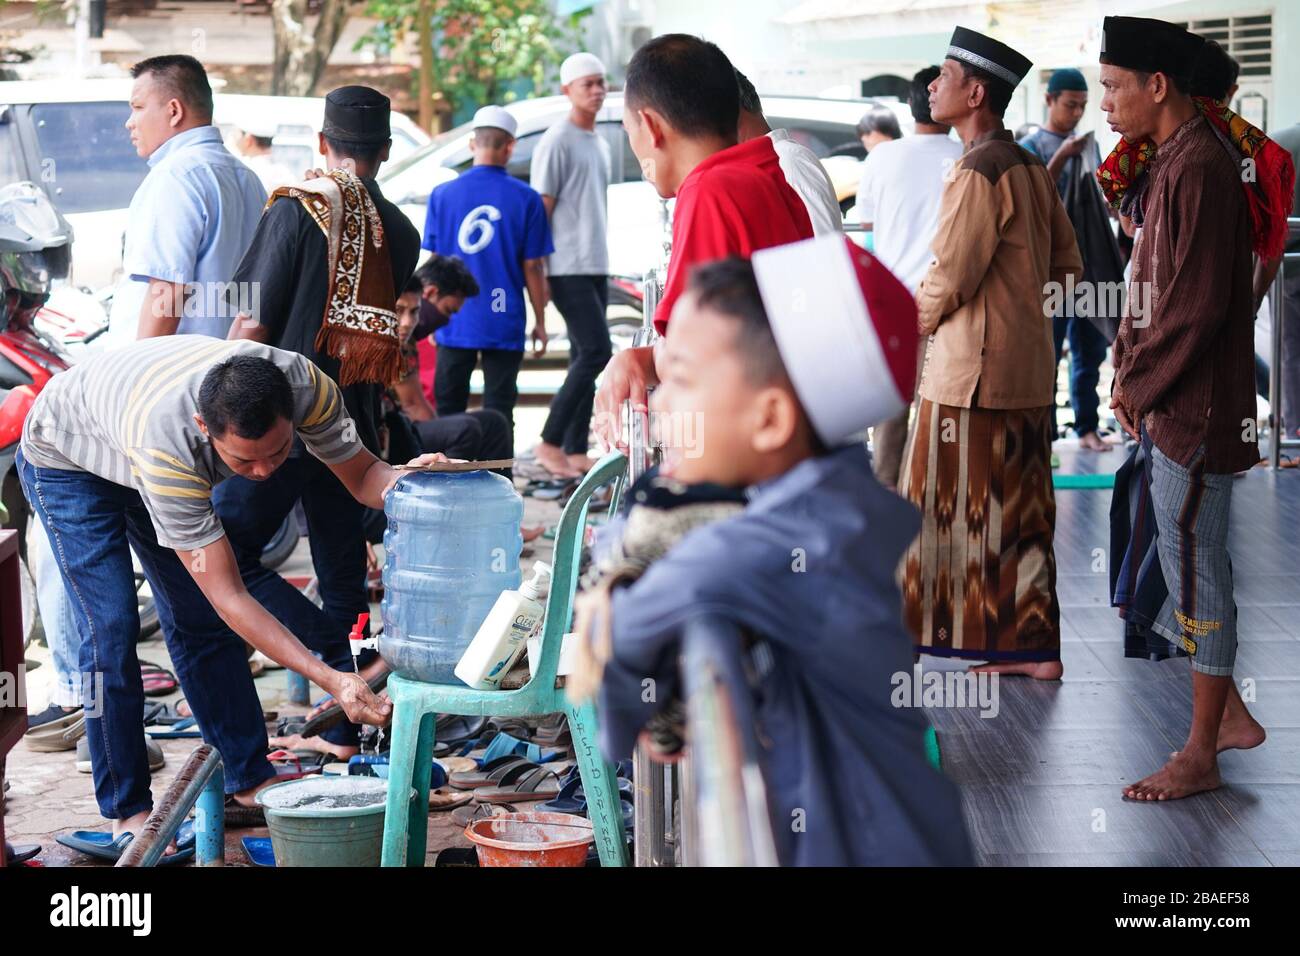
[382,451,628,866]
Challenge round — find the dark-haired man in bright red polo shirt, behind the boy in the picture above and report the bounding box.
[595,34,813,447]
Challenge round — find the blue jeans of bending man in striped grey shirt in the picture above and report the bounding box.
[17,450,276,819]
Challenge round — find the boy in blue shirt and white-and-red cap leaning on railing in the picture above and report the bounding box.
[568,235,971,866]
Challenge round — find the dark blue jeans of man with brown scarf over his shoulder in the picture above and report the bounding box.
[212,451,374,747]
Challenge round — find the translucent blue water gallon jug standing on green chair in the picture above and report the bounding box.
[380,471,524,684]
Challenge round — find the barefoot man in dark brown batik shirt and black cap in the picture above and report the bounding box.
[1101,17,1264,800]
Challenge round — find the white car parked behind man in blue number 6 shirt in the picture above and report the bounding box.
[378,92,911,277]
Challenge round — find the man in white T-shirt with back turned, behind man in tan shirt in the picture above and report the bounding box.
[858,66,962,488]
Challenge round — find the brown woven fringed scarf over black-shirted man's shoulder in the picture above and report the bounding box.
[267,169,402,385]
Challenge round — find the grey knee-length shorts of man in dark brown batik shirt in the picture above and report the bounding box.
[1151,445,1236,676]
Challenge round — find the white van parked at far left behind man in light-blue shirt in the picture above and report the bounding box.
[0,79,429,291]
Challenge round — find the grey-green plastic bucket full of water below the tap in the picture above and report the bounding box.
[257,777,415,866]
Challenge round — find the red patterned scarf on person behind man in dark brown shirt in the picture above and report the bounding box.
[1097,96,1296,259]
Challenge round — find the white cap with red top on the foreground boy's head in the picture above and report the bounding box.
[753,235,920,447]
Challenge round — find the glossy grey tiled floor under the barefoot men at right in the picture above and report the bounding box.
[924,449,1300,866]
